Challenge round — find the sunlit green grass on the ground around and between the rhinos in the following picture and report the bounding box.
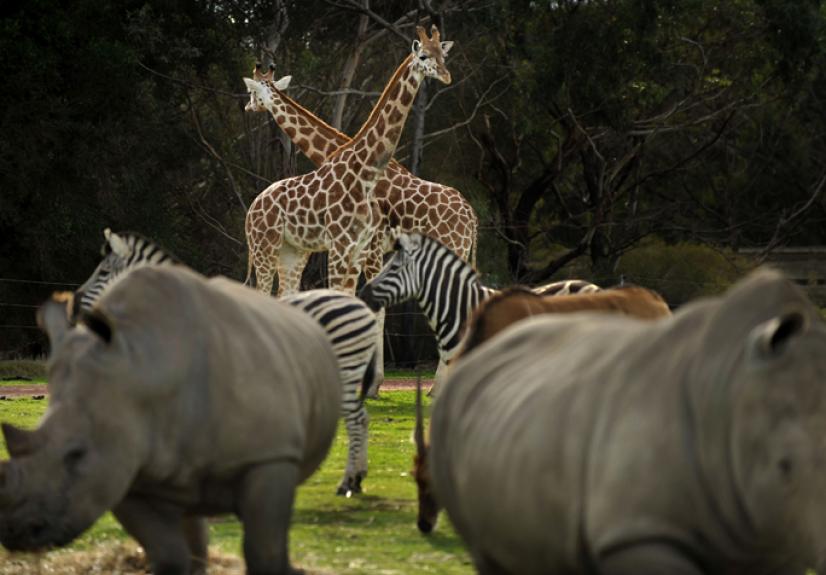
[0,391,473,575]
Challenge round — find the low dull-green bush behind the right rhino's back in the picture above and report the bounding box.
[617,241,753,306]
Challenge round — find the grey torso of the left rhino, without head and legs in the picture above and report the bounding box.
[99,268,340,484]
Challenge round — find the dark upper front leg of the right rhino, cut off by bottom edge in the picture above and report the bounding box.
[599,543,703,575]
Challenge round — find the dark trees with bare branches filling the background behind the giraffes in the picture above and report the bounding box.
[0,0,826,354]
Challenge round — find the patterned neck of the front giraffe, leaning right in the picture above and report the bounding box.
[332,55,424,174]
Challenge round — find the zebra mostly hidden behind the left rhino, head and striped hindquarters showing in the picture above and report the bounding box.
[72,228,379,497]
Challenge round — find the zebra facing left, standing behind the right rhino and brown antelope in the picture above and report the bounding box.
[359,233,601,391]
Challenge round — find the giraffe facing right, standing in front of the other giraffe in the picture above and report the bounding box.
[244,26,453,296]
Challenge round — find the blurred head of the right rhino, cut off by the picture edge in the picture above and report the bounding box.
[691,270,826,572]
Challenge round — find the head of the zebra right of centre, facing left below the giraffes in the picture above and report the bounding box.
[359,233,428,311]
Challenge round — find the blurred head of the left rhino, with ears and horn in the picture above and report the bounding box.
[0,299,145,550]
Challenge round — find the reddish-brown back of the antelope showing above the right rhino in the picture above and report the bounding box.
[459,286,671,357]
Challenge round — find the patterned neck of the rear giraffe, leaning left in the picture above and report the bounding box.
[260,85,350,166]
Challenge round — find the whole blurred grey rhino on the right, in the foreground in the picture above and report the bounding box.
[430,270,826,575]
